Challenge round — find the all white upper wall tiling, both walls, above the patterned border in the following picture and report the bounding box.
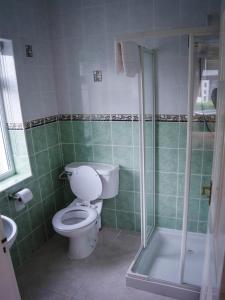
[0,0,220,120]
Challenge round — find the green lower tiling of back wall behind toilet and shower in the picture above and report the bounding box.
[60,121,213,232]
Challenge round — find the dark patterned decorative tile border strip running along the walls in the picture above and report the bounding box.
[7,114,216,130]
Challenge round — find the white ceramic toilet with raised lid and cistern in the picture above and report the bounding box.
[52,162,119,259]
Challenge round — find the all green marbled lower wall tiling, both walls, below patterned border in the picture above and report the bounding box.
[0,116,214,267]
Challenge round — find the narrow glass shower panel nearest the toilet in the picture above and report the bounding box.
[139,47,156,247]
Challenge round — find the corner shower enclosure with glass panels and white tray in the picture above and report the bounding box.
[126,28,219,299]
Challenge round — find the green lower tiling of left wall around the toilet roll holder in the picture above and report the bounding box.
[0,122,66,267]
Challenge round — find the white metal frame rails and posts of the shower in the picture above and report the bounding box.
[116,26,219,284]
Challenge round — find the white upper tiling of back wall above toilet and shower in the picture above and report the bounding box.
[49,0,220,114]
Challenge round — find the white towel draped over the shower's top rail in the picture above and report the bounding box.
[115,42,141,77]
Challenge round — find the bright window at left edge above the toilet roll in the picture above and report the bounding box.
[0,43,15,181]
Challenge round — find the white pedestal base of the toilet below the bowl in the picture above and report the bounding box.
[68,222,99,259]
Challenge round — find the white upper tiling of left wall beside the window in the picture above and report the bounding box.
[0,0,58,121]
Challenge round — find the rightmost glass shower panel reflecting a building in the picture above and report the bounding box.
[183,36,219,286]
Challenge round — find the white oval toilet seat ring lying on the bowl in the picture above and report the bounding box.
[52,205,98,231]
